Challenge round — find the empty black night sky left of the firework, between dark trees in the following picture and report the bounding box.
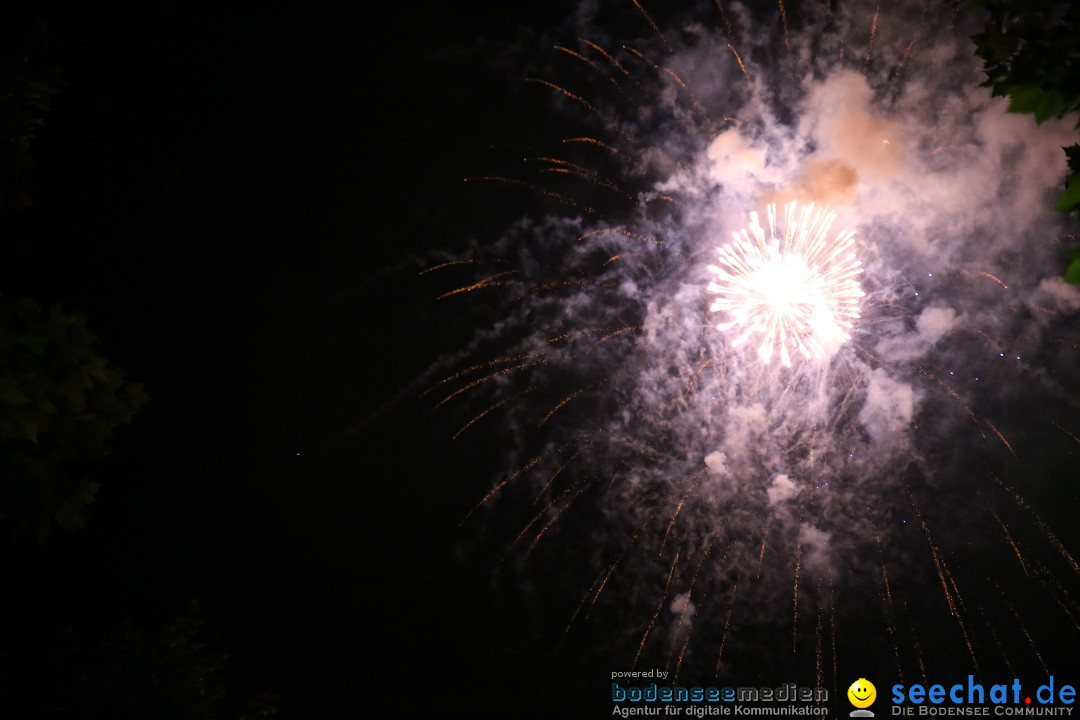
[0,1,1075,718]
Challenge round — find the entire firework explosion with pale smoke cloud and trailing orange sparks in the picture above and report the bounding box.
[424,2,1080,691]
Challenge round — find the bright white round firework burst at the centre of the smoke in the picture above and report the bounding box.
[708,200,863,367]
